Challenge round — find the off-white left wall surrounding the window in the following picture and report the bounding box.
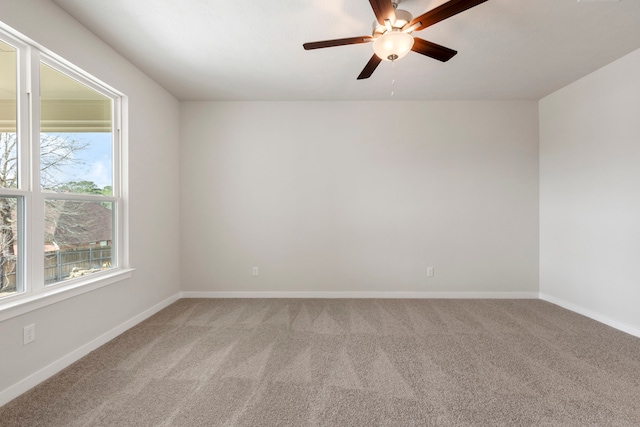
[0,0,179,404]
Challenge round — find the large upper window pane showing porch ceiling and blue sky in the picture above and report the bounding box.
[40,64,113,195]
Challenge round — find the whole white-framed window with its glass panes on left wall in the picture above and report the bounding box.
[0,24,126,309]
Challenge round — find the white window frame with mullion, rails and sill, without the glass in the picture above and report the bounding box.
[0,22,133,321]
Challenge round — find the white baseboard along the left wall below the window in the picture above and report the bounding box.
[0,293,180,406]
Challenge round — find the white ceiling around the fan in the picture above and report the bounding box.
[52,0,640,100]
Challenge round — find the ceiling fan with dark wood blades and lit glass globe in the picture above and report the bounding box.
[302,0,487,80]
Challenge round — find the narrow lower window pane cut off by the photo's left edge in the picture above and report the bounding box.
[0,197,22,298]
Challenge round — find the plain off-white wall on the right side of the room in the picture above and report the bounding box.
[540,46,640,336]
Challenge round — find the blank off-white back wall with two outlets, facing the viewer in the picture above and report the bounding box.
[181,101,538,296]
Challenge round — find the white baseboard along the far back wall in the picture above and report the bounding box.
[180,291,539,299]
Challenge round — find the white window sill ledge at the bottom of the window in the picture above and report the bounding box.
[0,268,134,322]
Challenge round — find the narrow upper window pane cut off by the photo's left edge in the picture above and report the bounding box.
[0,41,18,188]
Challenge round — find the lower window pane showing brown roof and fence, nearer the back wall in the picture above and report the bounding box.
[44,200,115,284]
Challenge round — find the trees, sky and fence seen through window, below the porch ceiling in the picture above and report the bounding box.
[0,132,113,296]
